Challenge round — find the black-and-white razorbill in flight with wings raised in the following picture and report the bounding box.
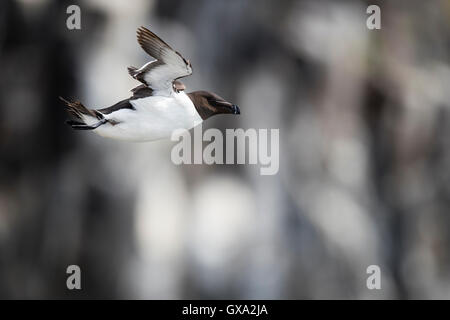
[59,26,241,142]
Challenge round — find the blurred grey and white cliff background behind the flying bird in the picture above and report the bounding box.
[0,0,450,299]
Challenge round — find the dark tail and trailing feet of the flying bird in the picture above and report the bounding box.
[59,97,107,130]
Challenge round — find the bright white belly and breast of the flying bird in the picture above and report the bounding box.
[94,92,203,141]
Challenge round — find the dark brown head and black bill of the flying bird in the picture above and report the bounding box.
[188,91,241,120]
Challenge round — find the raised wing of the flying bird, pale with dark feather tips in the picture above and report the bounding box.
[128,27,192,93]
